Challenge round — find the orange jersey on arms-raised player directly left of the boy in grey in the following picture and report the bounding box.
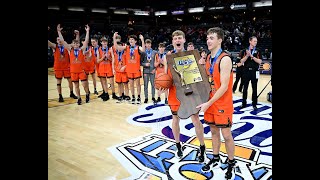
[124,46,140,73]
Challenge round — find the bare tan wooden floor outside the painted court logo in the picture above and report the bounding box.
[48,68,272,180]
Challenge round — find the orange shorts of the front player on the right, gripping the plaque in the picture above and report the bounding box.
[204,111,232,128]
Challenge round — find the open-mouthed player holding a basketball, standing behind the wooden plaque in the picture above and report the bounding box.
[161,30,206,163]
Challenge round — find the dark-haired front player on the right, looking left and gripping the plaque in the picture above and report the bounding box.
[197,27,236,179]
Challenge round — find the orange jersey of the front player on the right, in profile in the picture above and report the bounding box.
[206,52,234,115]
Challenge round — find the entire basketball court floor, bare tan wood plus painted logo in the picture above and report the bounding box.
[48,68,272,180]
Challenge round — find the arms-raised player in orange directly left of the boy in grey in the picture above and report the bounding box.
[113,32,145,104]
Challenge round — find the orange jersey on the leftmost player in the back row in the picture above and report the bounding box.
[53,45,70,70]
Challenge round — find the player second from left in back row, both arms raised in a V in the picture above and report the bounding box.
[57,24,90,105]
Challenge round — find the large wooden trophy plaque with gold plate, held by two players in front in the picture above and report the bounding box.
[167,50,211,119]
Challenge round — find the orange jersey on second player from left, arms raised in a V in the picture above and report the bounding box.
[70,48,84,73]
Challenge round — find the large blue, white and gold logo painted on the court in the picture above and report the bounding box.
[108,98,272,180]
